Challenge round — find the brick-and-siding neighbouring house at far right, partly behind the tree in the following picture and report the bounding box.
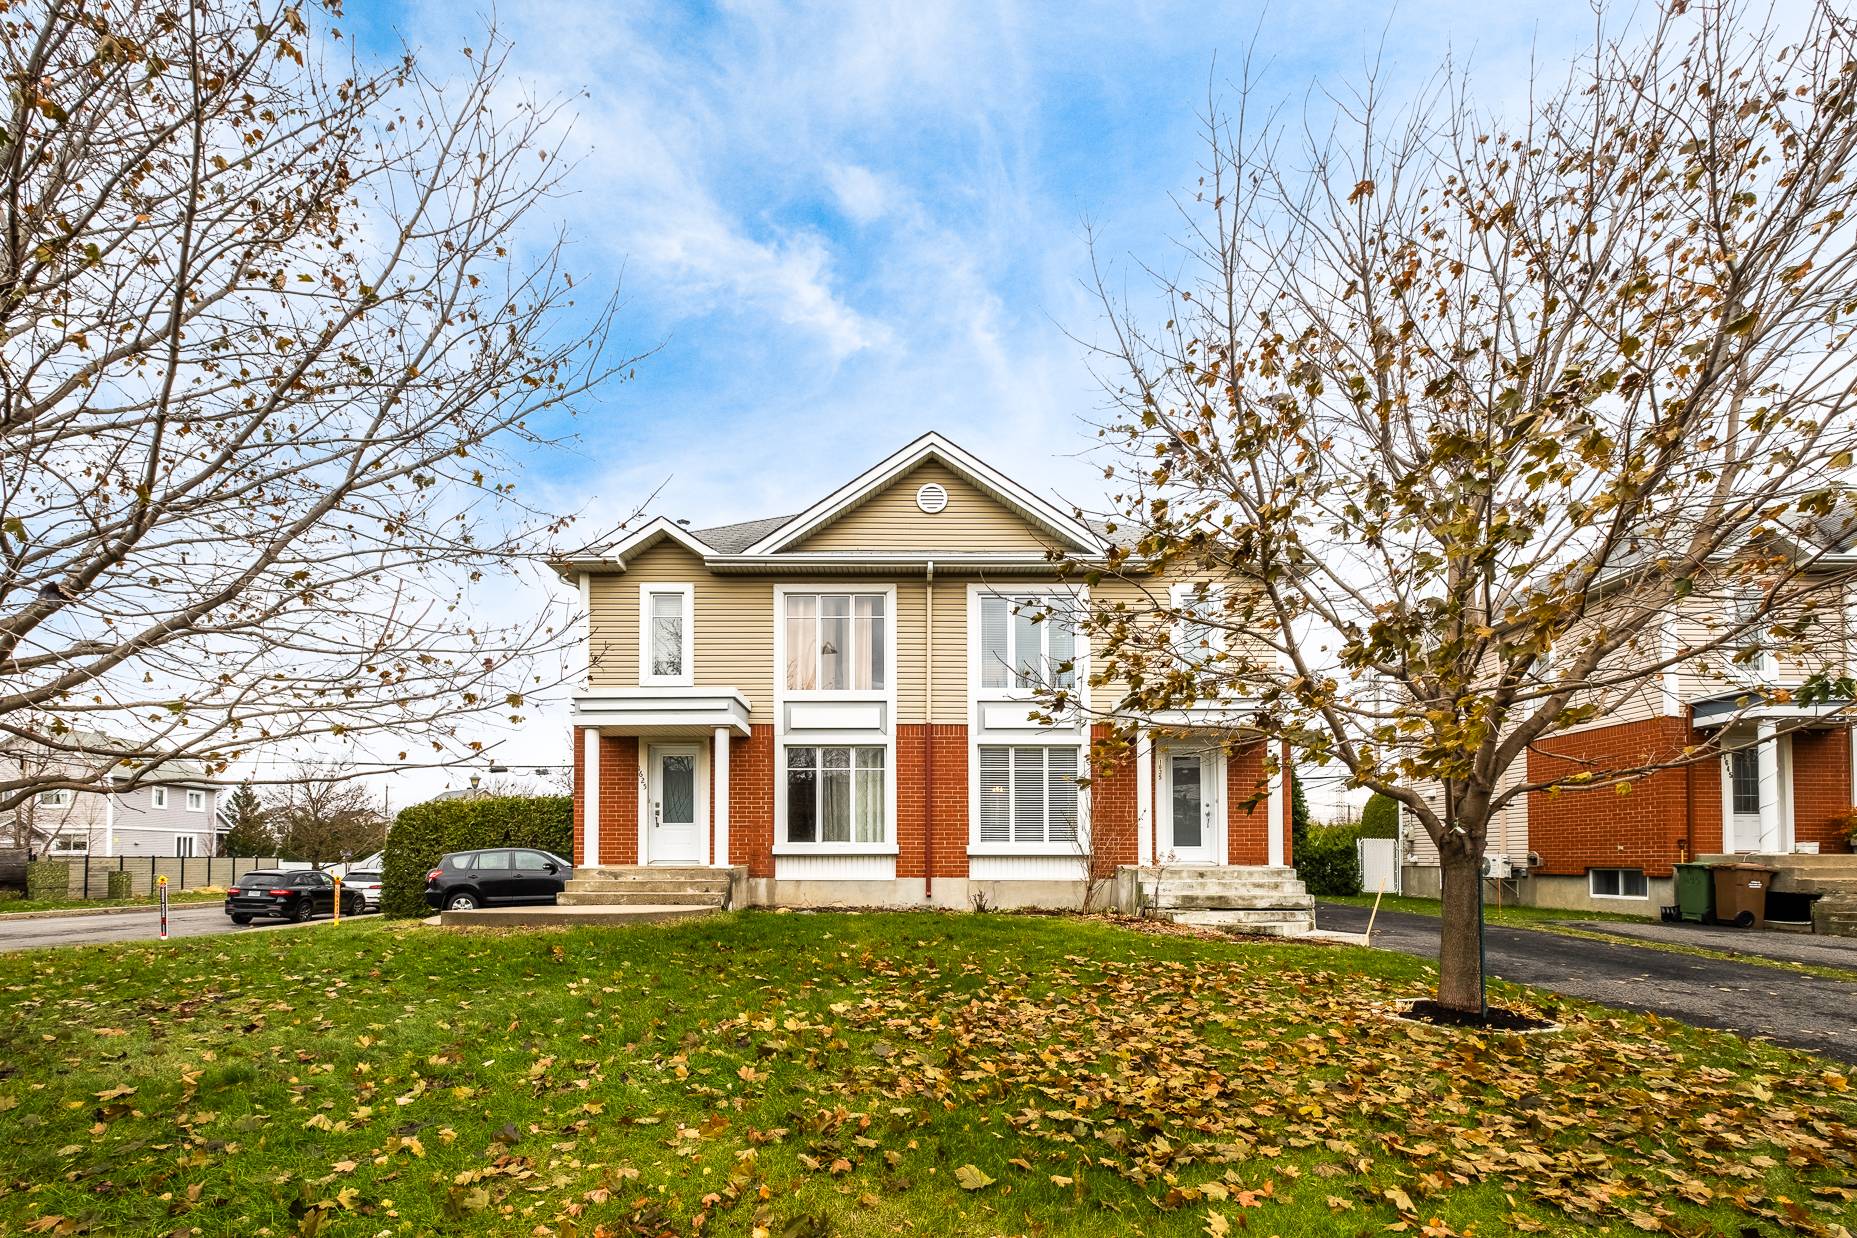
[1400,548,1857,915]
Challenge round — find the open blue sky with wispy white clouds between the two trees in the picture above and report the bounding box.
[347,0,1591,809]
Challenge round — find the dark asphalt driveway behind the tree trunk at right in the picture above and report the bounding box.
[1315,902,1857,1062]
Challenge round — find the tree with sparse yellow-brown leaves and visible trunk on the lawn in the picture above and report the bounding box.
[1069,0,1857,1010]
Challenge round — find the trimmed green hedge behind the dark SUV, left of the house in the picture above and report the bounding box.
[381,794,574,915]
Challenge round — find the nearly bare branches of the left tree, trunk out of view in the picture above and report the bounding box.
[0,0,626,809]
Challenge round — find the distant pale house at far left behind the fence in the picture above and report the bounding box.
[11,735,227,859]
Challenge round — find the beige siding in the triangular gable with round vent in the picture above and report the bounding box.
[793,460,1077,553]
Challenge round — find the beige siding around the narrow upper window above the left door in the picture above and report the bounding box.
[591,542,774,722]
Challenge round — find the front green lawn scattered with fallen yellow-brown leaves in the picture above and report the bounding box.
[0,911,1857,1238]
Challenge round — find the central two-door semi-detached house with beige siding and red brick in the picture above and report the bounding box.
[555,434,1289,906]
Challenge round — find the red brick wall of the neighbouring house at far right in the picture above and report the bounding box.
[1526,718,1851,876]
